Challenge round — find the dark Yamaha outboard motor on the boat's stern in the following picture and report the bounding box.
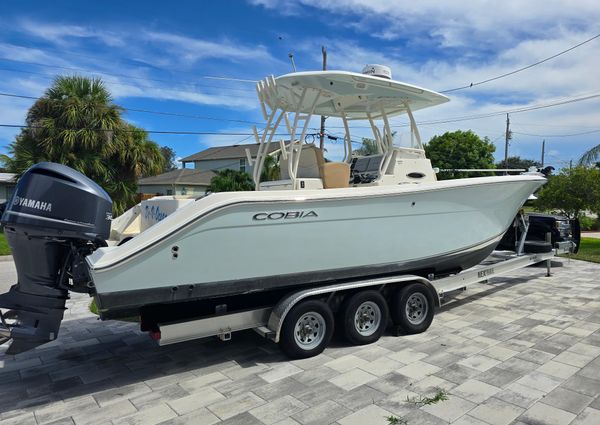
[0,162,112,354]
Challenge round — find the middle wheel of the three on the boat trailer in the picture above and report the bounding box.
[340,290,388,345]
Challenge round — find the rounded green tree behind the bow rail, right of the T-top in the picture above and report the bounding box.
[425,130,496,180]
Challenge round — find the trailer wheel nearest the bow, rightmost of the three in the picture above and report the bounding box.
[391,283,434,334]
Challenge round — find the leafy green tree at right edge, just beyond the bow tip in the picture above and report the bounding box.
[535,167,600,218]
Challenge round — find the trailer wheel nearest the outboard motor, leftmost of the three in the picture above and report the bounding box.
[279,300,334,359]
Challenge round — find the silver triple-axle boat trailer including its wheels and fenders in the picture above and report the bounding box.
[142,235,573,358]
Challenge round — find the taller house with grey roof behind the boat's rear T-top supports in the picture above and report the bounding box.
[181,142,281,175]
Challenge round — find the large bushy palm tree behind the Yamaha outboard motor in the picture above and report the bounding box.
[3,76,164,215]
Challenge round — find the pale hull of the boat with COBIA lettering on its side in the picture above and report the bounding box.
[87,176,545,310]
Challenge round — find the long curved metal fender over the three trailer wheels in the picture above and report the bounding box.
[267,275,440,343]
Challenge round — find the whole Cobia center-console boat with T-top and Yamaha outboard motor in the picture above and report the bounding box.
[0,66,546,353]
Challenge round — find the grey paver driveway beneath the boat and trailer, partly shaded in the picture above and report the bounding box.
[0,260,600,425]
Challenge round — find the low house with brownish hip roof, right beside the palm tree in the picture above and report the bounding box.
[138,168,215,197]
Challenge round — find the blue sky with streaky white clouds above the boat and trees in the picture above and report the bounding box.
[0,0,600,168]
